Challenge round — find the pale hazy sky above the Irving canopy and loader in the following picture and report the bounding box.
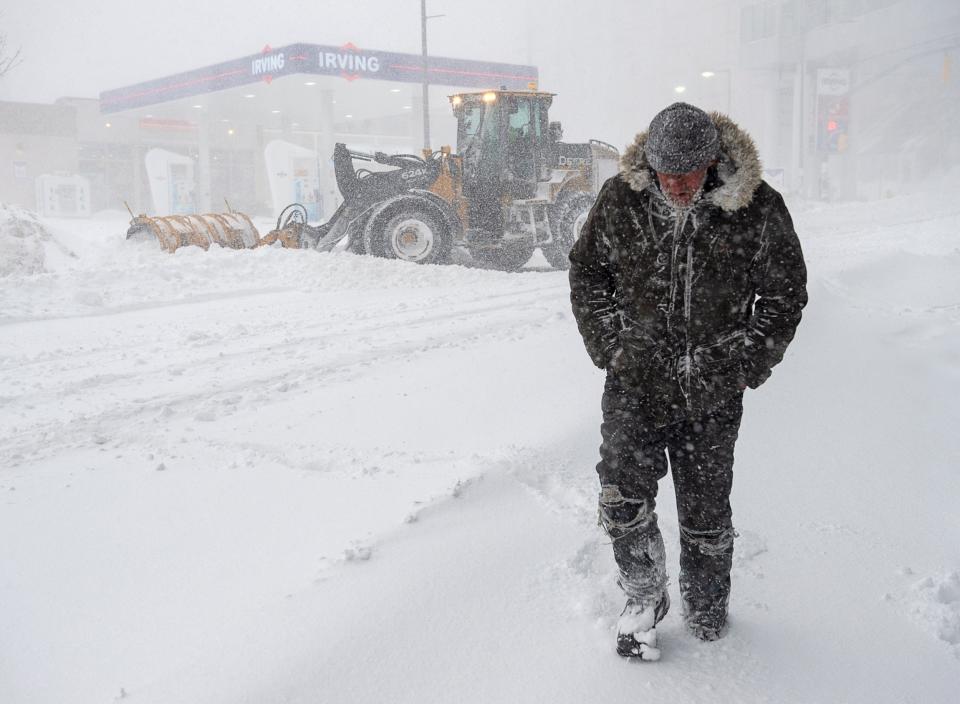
[0,0,737,145]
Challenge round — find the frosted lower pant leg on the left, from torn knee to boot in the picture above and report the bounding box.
[600,485,667,604]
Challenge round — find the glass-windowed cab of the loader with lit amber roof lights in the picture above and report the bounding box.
[450,90,554,231]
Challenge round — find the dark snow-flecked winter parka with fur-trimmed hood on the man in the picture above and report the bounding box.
[570,113,807,425]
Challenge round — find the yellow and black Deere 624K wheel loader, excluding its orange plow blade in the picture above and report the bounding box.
[128,90,619,271]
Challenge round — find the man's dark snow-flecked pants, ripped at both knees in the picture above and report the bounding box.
[597,382,743,630]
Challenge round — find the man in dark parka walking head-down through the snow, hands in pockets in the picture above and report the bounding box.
[570,103,807,660]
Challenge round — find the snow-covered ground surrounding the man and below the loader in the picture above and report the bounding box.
[0,182,960,704]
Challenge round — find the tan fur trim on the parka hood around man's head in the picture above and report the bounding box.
[620,112,763,211]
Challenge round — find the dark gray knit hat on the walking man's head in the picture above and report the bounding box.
[644,103,720,174]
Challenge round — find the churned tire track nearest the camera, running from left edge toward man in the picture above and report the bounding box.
[0,280,566,462]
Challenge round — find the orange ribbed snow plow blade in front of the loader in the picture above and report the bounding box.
[127,212,260,252]
